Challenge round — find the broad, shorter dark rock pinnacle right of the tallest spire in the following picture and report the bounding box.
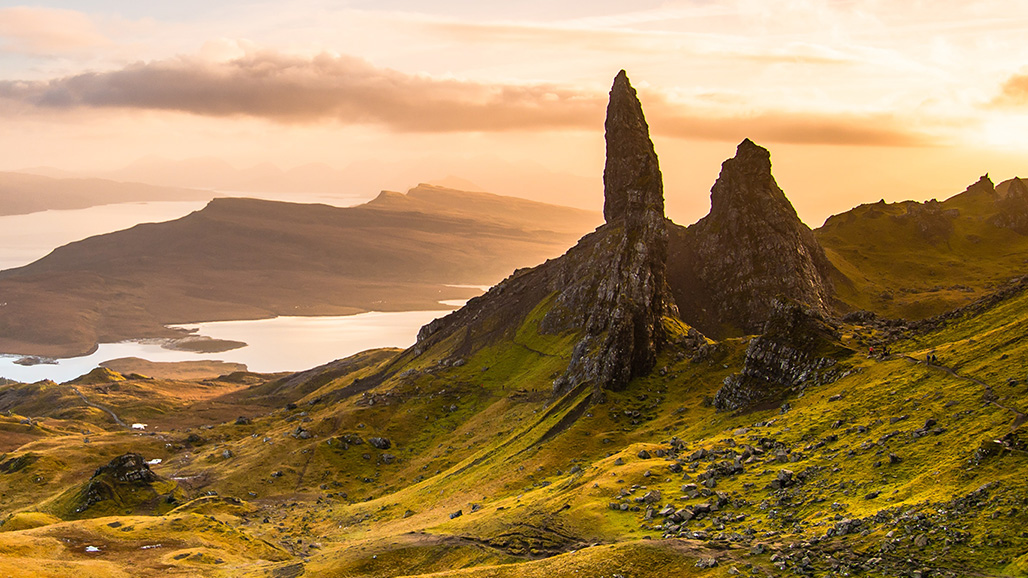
[667,139,834,337]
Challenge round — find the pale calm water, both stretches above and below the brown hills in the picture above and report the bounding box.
[0,193,470,383]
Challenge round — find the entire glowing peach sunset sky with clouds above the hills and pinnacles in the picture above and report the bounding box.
[0,0,1028,226]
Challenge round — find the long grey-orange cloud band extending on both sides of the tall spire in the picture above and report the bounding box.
[0,50,924,146]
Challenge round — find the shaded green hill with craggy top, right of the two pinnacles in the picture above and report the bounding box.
[815,179,1028,319]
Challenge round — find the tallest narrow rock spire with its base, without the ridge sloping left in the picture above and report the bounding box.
[555,70,676,391]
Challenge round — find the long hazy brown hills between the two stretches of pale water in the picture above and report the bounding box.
[0,186,599,356]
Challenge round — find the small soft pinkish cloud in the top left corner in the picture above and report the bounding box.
[0,6,110,56]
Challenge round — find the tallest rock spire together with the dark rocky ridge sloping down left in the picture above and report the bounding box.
[415,71,676,393]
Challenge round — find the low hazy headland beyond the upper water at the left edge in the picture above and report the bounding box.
[0,173,216,215]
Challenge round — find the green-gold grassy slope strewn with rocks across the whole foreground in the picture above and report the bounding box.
[0,271,1028,577]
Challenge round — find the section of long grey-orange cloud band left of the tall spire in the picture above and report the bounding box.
[0,51,602,132]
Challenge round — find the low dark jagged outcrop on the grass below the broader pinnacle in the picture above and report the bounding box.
[713,298,852,411]
